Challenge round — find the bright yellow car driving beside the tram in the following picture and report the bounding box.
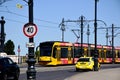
[75,57,100,71]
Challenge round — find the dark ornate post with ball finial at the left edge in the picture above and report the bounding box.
[0,16,5,52]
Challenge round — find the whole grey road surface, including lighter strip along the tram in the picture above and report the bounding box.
[19,64,120,80]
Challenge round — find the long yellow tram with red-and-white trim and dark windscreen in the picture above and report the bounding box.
[38,41,120,65]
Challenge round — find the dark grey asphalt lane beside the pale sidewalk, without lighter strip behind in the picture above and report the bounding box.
[19,70,78,80]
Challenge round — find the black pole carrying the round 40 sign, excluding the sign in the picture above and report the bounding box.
[27,0,36,80]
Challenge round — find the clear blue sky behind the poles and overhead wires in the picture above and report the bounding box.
[0,0,120,55]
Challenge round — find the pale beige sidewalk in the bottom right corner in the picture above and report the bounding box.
[65,68,120,80]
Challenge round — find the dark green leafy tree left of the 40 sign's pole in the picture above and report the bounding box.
[4,40,15,55]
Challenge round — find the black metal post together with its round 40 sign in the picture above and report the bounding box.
[23,0,37,80]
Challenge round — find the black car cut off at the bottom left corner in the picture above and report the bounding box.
[0,57,20,80]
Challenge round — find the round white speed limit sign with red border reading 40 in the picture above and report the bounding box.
[23,23,38,38]
